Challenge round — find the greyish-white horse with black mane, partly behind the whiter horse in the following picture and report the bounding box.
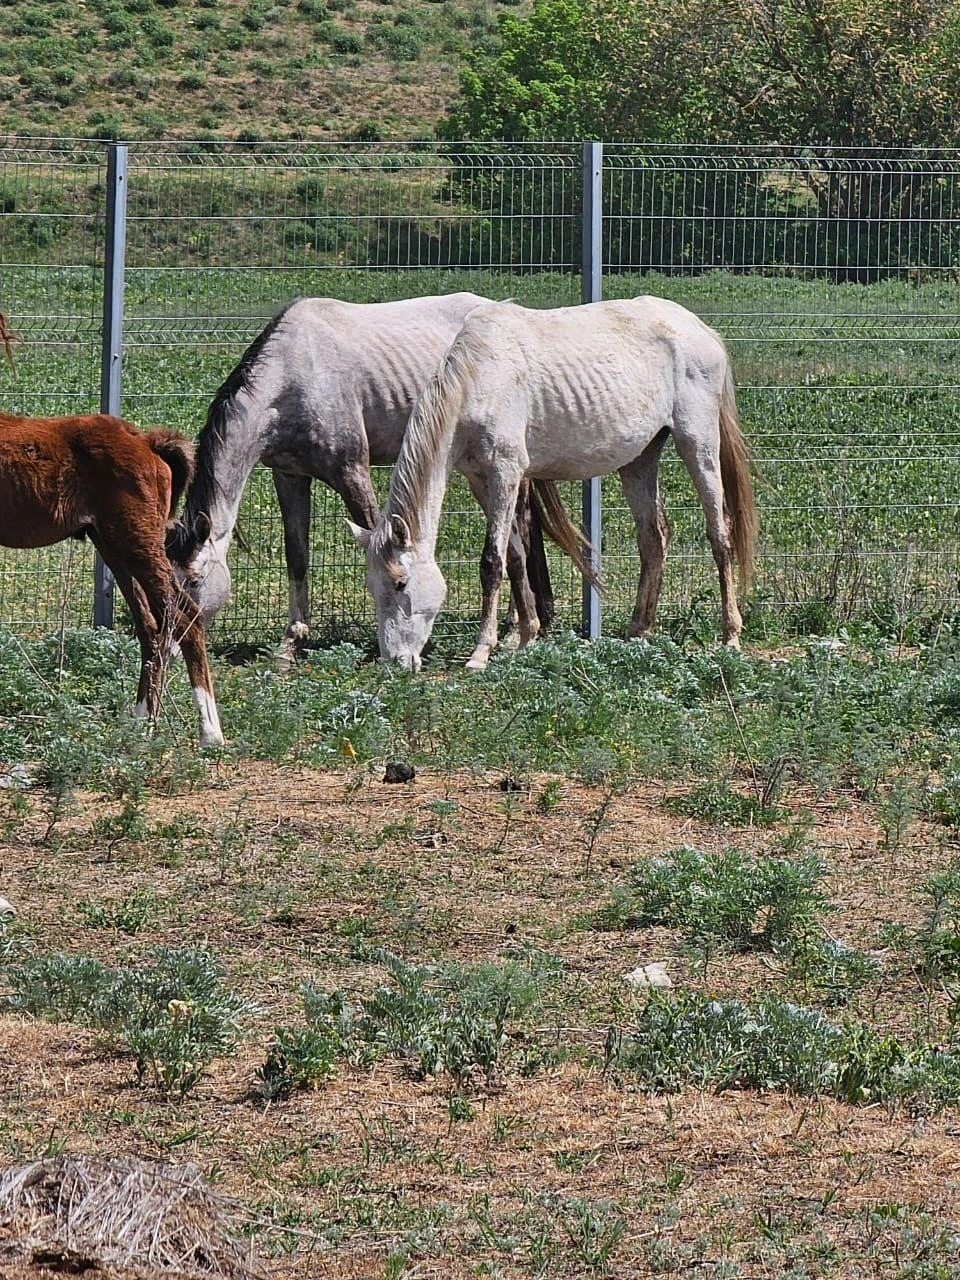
[168,293,553,655]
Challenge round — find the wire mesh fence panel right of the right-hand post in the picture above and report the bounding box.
[604,146,960,628]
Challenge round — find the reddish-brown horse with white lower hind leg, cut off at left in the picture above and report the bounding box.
[0,409,223,746]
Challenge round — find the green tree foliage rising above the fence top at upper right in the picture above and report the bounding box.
[444,0,960,147]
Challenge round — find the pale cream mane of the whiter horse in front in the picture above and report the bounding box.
[387,330,476,539]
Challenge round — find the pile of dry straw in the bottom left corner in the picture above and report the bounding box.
[0,1156,261,1280]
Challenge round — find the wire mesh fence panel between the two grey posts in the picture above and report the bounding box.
[123,143,581,643]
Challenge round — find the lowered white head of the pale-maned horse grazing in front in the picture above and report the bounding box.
[347,515,447,671]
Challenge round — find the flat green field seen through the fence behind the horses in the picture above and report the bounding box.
[0,268,960,652]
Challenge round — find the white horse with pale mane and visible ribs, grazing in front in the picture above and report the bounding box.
[351,297,756,669]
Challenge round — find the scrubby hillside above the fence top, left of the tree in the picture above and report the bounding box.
[0,0,519,141]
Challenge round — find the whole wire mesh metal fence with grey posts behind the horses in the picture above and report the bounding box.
[0,141,960,641]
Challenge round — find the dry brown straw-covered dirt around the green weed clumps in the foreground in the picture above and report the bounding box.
[0,764,960,1280]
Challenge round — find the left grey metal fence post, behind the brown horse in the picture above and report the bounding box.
[93,143,127,627]
